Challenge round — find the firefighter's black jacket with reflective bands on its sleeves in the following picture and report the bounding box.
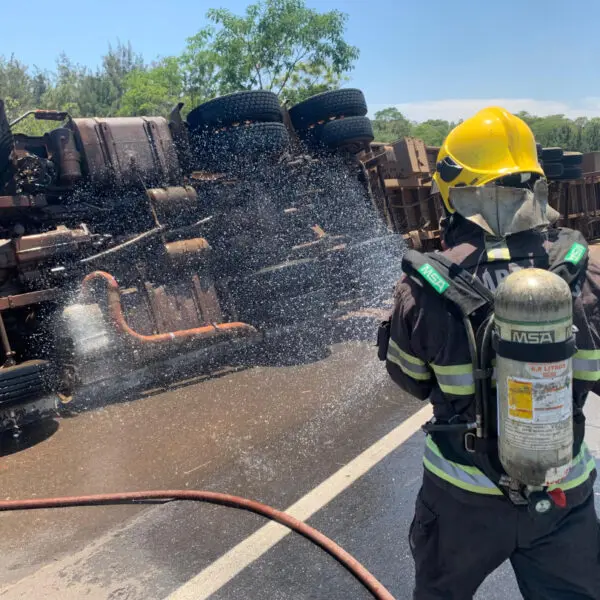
[386,221,600,474]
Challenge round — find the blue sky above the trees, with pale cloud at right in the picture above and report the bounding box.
[0,0,600,120]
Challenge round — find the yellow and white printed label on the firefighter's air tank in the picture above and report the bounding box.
[507,375,573,424]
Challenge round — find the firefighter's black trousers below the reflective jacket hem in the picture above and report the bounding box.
[409,471,600,600]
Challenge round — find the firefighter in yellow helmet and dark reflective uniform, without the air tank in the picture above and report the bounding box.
[378,107,600,600]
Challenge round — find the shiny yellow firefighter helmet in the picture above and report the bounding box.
[433,106,544,213]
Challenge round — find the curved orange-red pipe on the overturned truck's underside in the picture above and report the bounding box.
[81,271,256,344]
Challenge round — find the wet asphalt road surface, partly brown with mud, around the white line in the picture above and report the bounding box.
[0,342,600,600]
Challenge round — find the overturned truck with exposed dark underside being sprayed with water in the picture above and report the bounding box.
[0,89,402,432]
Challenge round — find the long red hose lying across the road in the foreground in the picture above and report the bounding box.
[0,490,395,600]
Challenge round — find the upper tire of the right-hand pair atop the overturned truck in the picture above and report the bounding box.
[289,88,368,131]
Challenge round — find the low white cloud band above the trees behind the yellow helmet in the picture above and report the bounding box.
[369,97,600,121]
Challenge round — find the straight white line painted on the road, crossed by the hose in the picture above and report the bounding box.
[165,403,432,600]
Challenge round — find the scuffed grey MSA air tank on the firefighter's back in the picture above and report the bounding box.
[494,268,575,486]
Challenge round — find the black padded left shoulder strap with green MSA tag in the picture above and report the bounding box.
[402,250,494,317]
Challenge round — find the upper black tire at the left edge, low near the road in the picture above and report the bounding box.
[0,360,53,405]
